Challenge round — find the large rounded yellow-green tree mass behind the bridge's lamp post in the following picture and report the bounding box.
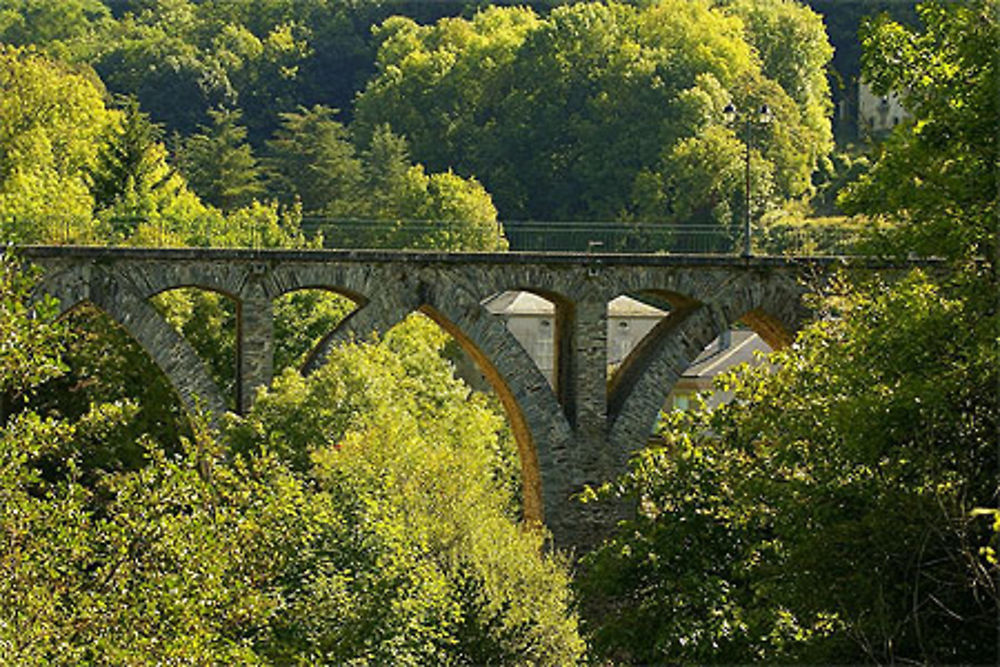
[356,1,830,227]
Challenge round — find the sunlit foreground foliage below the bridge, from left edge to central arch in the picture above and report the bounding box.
[0,254,582,664]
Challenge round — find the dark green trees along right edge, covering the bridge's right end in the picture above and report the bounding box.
[581,0,1000,664]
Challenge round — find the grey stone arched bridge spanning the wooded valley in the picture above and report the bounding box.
[21,246,838,546]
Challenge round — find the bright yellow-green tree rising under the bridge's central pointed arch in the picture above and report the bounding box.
[227,318,581,664]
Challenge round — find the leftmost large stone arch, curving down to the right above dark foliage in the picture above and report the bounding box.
[39,266,226,425]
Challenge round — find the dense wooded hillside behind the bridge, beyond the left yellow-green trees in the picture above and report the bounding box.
[0,0,848,247]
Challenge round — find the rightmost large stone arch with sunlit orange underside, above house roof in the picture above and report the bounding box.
[608,274,804,451]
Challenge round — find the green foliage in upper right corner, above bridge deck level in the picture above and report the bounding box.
[842,0,1000,272]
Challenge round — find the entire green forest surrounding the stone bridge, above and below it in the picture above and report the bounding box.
[0,0,1000,665]
